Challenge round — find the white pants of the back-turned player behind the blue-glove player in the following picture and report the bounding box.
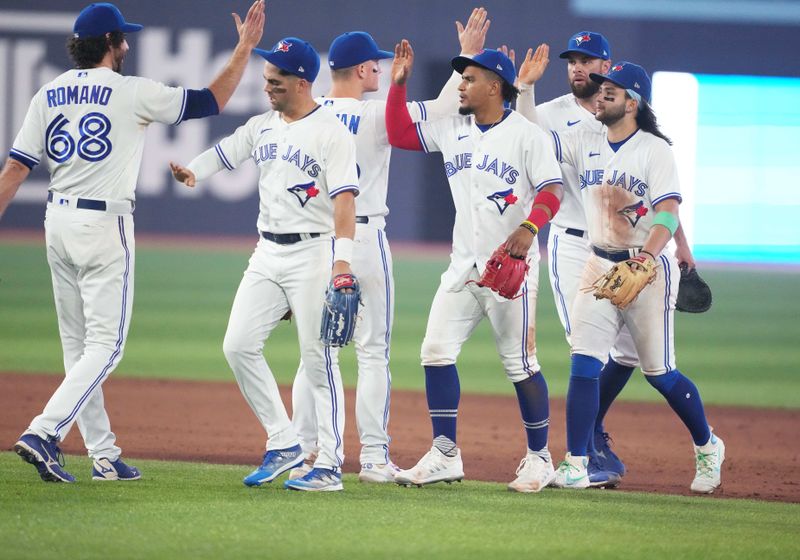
[292,217,394,465]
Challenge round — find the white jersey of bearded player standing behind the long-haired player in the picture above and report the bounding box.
[536,93,603,231]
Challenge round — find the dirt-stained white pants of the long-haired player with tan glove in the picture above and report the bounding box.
[572,252,681,375]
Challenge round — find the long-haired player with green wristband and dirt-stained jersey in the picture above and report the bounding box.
[552,62,725,493]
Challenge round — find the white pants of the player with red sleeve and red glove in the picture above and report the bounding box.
[421,266,540,383]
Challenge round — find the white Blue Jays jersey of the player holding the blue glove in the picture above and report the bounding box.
[188,106,358,233]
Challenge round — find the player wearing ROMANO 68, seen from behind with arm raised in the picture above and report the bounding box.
[0,0,264,482]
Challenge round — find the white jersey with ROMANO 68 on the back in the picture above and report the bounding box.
[11,67,186,200]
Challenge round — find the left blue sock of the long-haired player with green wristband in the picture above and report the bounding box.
[567,354,603,456]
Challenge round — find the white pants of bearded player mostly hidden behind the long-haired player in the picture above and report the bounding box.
[547,224,639,367]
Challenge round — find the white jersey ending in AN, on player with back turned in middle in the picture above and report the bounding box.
[316,97,428,216]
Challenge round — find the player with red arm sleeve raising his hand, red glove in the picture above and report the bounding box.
[386,41,561,492]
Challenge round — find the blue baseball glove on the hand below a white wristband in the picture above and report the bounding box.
[319,274,361,346]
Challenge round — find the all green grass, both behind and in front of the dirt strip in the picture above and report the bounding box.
[0,242,800,560]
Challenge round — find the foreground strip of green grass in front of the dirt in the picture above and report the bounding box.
[0,453,800,560]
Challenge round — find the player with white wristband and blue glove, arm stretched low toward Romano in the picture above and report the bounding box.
[172,37,358,491]
